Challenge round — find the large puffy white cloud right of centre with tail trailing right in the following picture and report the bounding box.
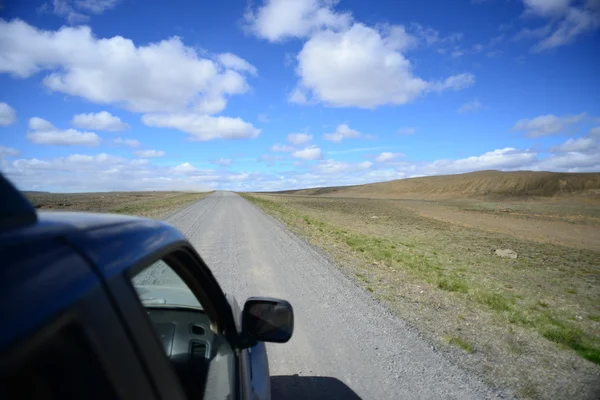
[290,23,475,108]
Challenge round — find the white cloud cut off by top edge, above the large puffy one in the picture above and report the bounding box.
[244,0,352,42]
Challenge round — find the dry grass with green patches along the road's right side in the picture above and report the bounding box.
[241,194,600,399]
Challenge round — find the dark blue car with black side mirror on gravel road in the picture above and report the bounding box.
[0,175,294,400]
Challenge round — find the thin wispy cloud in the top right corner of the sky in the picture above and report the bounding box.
[515,0,600,53]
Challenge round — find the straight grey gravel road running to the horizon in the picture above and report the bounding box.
[167,192,506,399]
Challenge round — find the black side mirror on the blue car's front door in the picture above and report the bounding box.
[242,297,294,347]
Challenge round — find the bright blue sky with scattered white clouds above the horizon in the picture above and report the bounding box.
[0,0,600,192]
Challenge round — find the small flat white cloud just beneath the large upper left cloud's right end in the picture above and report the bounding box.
[142,113,260,141]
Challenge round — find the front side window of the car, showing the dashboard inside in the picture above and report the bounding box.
[129,258,236,399]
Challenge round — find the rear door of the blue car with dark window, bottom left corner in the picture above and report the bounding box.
[0,235,157,400]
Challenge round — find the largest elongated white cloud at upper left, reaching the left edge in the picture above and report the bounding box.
[0,20,253,113]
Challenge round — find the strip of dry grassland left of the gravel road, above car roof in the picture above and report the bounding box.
[24,192,209,218]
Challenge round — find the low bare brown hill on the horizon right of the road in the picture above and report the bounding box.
[270,171,600,199]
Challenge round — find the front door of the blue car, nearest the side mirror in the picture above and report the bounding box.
[102,243,248,399]
